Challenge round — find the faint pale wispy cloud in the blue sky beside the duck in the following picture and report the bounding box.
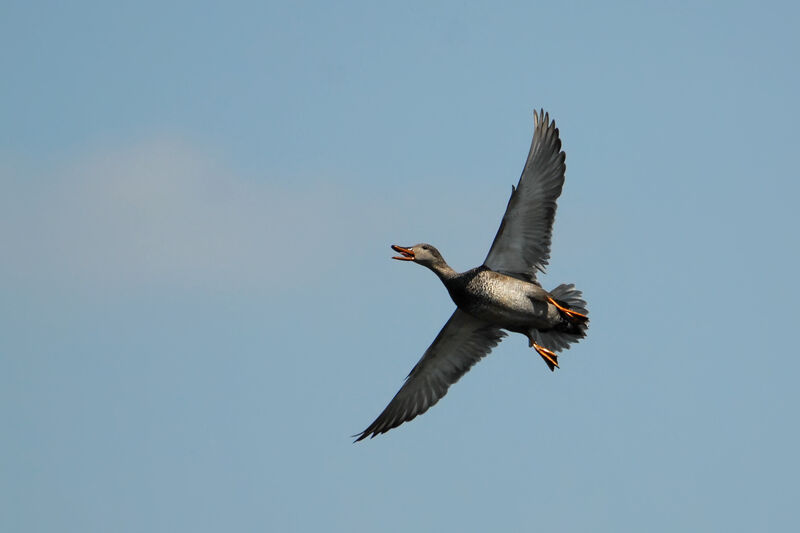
[0,139,386,287]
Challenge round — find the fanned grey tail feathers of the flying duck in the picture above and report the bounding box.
[530,283,589,370]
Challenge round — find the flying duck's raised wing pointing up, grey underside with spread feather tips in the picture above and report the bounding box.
[484,111,567,281]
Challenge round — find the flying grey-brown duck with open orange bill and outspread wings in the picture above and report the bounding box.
[353,109,589,442]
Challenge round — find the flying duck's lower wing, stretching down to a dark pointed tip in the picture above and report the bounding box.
[354,309,506,442]
